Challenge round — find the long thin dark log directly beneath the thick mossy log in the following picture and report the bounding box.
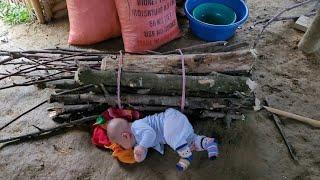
[50,93,253,110]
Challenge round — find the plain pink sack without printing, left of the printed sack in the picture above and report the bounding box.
[67,0,121,45]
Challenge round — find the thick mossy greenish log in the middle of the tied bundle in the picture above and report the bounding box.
[75,67,250,97]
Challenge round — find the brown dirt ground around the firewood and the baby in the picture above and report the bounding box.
[0,0,320,180]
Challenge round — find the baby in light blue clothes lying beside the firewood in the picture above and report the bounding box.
[107,108,219,171]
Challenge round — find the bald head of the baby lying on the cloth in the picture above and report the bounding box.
[107,118,135,149]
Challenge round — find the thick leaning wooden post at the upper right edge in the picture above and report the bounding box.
[298,9,320,54]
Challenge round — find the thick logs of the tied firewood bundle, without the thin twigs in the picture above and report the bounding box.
[46,50,254,121]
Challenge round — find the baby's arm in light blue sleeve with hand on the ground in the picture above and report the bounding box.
[133,126,156,162]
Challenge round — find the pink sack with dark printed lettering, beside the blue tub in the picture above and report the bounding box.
[115,0,180,52]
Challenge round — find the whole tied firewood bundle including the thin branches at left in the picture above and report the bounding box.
[0,42,255,126]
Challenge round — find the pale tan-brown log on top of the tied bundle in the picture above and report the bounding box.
[101,50,255,74]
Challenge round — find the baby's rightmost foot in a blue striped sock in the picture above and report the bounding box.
[194,135,219,160]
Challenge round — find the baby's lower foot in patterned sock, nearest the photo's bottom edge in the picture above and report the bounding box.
[176,143,192,171]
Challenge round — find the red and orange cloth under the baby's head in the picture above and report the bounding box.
[91,108,141,164]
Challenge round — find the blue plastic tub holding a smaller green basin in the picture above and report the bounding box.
[184,0,249,41]
